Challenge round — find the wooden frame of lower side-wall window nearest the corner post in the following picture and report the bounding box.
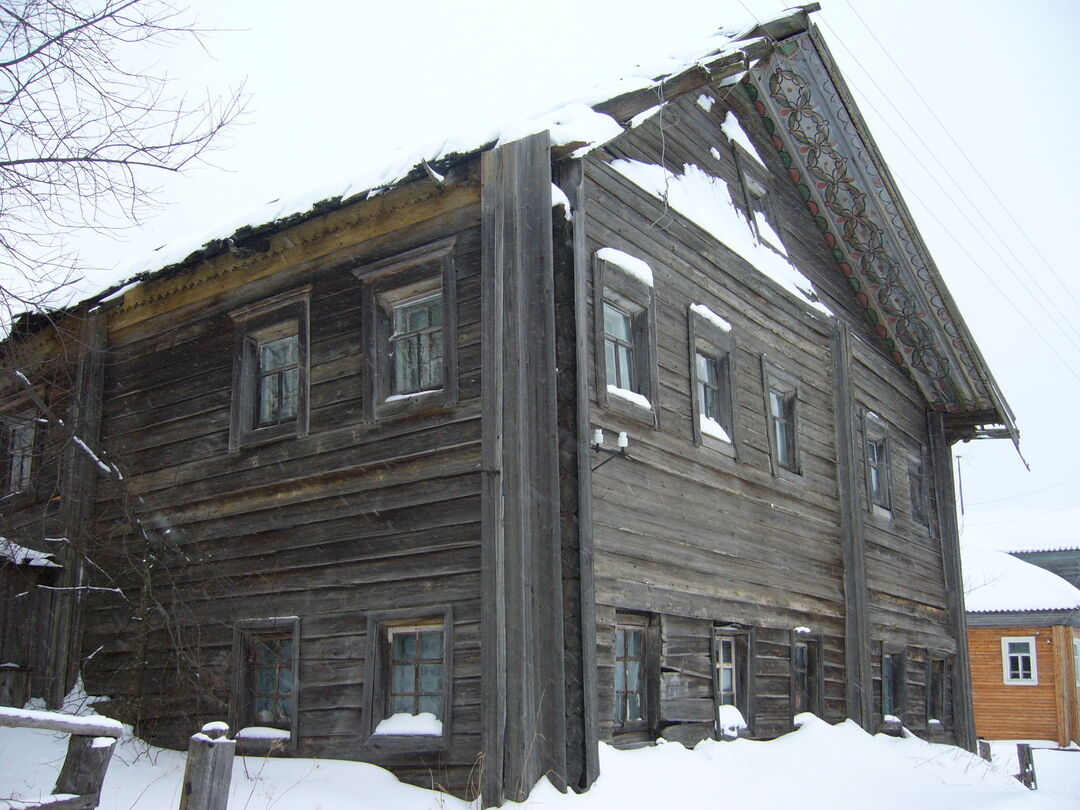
[361,605,454,752]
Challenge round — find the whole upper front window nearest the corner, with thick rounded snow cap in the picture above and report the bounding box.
[593,247,659,427]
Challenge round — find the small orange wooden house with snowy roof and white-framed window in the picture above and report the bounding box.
[963,548,1080,745]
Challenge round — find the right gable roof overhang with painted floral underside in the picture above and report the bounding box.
[741,23,1018,441]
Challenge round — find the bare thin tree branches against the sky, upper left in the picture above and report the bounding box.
[0,0,243,325]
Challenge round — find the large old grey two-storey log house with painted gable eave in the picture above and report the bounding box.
[0,4,1015,802]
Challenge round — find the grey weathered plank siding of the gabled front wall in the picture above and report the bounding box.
[585,90,957,739]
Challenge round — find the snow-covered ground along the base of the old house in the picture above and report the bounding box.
[0,691,1080,810]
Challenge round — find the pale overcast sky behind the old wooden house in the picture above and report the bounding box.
[46,0,1080,542]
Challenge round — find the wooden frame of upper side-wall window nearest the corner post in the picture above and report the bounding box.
[352,235,458,421]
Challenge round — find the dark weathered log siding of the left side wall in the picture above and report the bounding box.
[84,167,481,791]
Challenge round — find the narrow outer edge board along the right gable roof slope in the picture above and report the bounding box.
[803,21,1027,447]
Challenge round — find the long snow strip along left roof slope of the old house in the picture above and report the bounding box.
[63,22,777,313]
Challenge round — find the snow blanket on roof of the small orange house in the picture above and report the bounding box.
[961,543,1080,613]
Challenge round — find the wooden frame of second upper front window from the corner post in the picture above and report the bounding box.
[687,305,742,458]
